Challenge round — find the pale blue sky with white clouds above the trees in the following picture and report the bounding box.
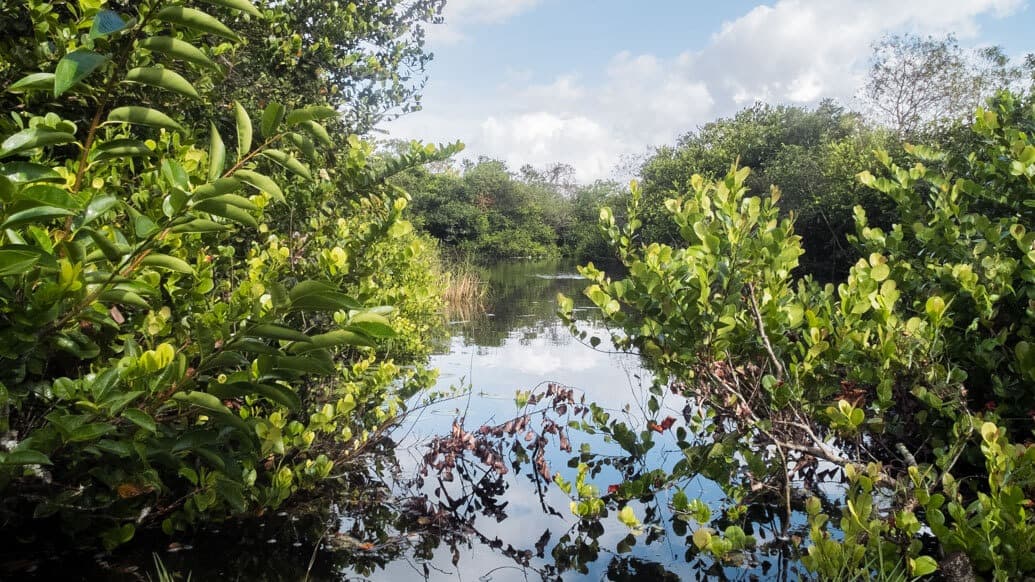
[384,0,1035,182]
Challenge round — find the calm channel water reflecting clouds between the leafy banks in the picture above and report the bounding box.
[10,262,804,581]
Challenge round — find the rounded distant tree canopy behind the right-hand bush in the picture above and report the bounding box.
[641,100,895,279]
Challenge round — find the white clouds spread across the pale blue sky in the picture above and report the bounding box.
[392,0,1024,180]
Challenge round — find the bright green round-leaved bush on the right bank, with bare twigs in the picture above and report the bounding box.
[562,94,1035,580]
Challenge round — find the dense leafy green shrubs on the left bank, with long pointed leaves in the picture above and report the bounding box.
[0,0,451,547]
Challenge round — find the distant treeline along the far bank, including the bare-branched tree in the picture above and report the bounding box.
[397,35,1035,281]
